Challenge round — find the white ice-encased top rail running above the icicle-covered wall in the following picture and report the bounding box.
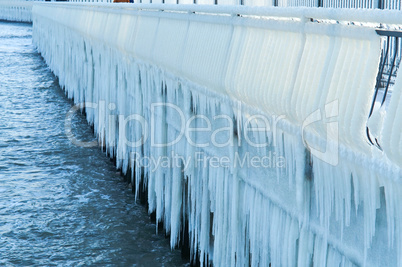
[41,2,401,23]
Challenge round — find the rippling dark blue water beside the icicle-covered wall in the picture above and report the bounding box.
[0,22,185,266]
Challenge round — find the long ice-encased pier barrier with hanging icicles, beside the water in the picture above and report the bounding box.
[33,3,402,266]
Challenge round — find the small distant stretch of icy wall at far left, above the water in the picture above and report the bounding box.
[0,0,33,22]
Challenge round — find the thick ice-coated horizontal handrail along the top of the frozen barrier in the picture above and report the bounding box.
[35,2,402,25]
